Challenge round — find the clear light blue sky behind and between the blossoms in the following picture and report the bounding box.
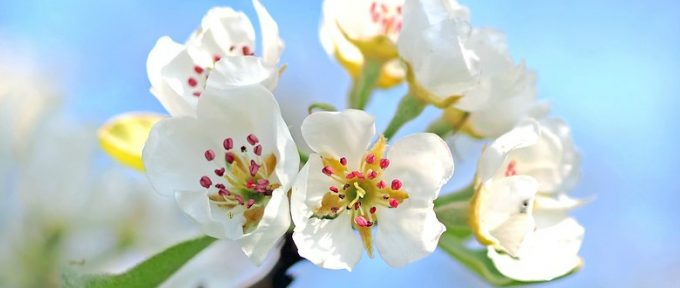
[0,0,680,287]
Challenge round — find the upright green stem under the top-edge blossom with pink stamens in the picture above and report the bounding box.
[348,57,385,110]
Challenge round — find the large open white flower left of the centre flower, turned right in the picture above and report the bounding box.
[142,85,300,263]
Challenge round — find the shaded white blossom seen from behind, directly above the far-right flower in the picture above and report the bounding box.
[444,29,549,138]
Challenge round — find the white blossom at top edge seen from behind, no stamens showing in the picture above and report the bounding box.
[397,0,483,109]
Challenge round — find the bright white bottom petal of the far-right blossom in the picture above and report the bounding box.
[488,218,585,281]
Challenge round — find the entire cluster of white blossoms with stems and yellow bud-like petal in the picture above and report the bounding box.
[91,0,584,282]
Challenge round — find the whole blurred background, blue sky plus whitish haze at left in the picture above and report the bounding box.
[0,0,680,287]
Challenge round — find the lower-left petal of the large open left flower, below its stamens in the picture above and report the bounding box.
[175,191,245,240]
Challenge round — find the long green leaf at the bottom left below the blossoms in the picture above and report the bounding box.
[62,236,215,288]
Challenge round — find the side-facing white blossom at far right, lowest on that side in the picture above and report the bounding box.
[471,120,584,281]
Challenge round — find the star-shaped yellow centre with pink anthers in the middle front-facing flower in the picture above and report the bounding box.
[312,136,409,256]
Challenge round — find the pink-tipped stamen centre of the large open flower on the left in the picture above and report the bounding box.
[199,134,281,233]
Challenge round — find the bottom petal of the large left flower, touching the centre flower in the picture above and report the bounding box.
[239,188,290,265]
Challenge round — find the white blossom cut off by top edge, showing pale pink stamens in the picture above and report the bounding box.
[319,0,405,87]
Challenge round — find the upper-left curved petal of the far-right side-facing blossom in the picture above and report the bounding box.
[477,120,540,182]
